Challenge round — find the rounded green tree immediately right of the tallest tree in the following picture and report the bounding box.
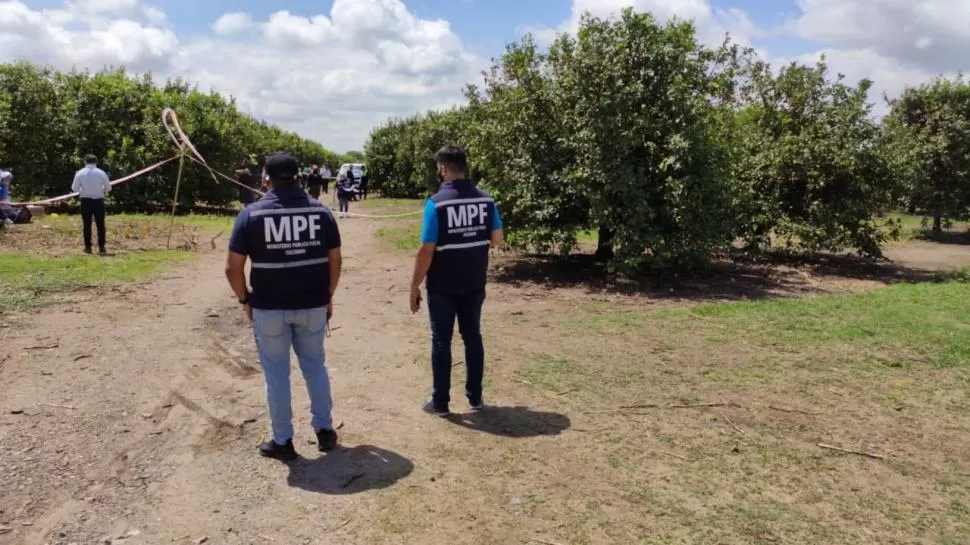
[732,56,892,256]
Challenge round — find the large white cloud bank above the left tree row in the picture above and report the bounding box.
[0,0,485,151]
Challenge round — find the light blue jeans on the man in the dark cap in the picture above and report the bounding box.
[253,307,333,445]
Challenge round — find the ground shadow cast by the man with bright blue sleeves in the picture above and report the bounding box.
[448,406,570,438]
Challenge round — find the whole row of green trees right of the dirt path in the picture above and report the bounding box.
[366,9,970,266]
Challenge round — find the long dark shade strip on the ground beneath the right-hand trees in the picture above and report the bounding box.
[491,249,936,301]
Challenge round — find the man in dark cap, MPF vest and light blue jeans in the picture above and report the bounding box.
[226,153,341,461]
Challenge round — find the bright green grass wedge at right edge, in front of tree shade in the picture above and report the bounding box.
[655,282,970,367]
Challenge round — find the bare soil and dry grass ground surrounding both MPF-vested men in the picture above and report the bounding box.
[0,214,970,545]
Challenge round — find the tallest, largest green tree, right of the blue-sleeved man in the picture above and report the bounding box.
[469,9,735,266]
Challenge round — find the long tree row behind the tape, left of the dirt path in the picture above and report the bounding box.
[0,63,343,210]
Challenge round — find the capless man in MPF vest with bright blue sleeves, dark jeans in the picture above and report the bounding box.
[411,146,505,416]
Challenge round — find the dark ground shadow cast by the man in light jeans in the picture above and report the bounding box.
[286,445,414,495]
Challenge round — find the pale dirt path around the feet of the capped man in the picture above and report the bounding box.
[0,220,516,545]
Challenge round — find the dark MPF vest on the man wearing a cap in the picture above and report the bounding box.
[240,187,340,310]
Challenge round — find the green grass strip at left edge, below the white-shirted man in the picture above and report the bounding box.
[0,250,193,312]
